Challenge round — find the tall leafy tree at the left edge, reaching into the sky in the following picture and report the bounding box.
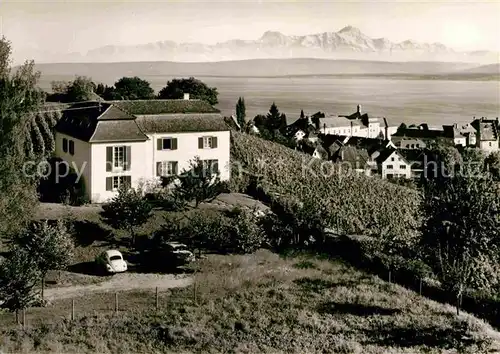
[0,38,44,238]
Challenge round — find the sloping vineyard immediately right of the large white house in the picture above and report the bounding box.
[231,132,421,238]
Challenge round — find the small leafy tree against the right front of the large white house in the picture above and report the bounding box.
[173,157,223,208]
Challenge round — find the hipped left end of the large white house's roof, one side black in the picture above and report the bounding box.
[55,102,148,143]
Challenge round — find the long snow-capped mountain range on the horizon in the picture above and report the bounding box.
[39,26,499,63]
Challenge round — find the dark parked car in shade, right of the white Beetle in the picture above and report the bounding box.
[146,242,196,269]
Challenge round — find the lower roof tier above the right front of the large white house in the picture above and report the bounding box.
[137,113,229,133]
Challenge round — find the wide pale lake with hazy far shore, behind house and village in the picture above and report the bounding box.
[38,60,500,125]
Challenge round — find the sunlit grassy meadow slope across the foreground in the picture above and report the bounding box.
[0,251,500,354]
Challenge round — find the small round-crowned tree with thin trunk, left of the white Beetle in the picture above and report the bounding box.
[14,220,75,299]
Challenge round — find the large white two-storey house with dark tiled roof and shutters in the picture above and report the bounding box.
[55,99,230,203]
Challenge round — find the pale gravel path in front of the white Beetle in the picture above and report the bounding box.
[44,272,192,301]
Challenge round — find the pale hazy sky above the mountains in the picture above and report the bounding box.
[0,0,500,62]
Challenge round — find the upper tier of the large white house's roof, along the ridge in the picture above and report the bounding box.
[108,99,220,115]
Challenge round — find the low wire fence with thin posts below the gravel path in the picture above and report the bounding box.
[0,284,199,329]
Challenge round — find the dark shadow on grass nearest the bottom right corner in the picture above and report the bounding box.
[365,323,491,352]
